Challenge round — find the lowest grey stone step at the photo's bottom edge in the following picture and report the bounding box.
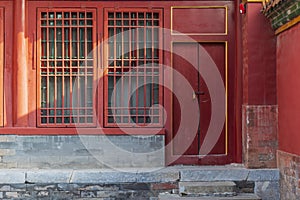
[158,193,261,200]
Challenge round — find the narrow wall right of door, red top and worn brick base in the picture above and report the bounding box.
[242,3,278,168]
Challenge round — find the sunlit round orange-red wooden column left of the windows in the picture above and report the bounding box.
[13,0,28,126]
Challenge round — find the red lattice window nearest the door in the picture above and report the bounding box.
[104,9,162,127]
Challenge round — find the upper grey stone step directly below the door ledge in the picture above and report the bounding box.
[179,181,236,196]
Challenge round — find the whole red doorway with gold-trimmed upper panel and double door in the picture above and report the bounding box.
[167,2,236,165]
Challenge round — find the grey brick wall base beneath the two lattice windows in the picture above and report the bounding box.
[0,135,165,169]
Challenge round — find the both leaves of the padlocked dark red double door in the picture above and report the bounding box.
[172,42,228,162]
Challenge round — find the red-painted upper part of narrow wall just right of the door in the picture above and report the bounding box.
[243,3,277,105]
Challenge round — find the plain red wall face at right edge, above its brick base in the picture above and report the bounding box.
[277,24,300,155]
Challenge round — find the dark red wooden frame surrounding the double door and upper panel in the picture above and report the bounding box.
[165,2,242,165]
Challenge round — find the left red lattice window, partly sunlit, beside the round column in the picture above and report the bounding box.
[37,9,96,127]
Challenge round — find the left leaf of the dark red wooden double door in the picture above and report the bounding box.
[173,43,199,155]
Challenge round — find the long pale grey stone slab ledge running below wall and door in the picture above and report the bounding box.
[0,167,280,184]
